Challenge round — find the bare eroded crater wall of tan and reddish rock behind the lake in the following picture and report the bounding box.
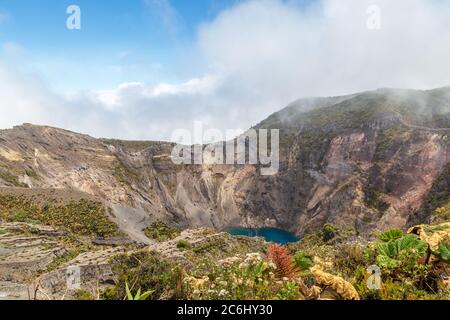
[0,89,450,237]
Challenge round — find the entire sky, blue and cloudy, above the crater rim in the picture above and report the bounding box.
[0,0,450,140]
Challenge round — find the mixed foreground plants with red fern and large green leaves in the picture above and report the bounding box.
[102,224,450,300]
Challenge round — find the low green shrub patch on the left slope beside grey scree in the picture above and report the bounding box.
[0,194,118,237]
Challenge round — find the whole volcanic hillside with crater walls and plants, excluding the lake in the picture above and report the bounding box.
[0,88,450,300]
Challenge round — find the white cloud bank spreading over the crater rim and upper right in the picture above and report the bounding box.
[0,0,450,139]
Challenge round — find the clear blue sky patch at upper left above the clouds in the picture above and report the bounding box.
[0,0,246,90]
